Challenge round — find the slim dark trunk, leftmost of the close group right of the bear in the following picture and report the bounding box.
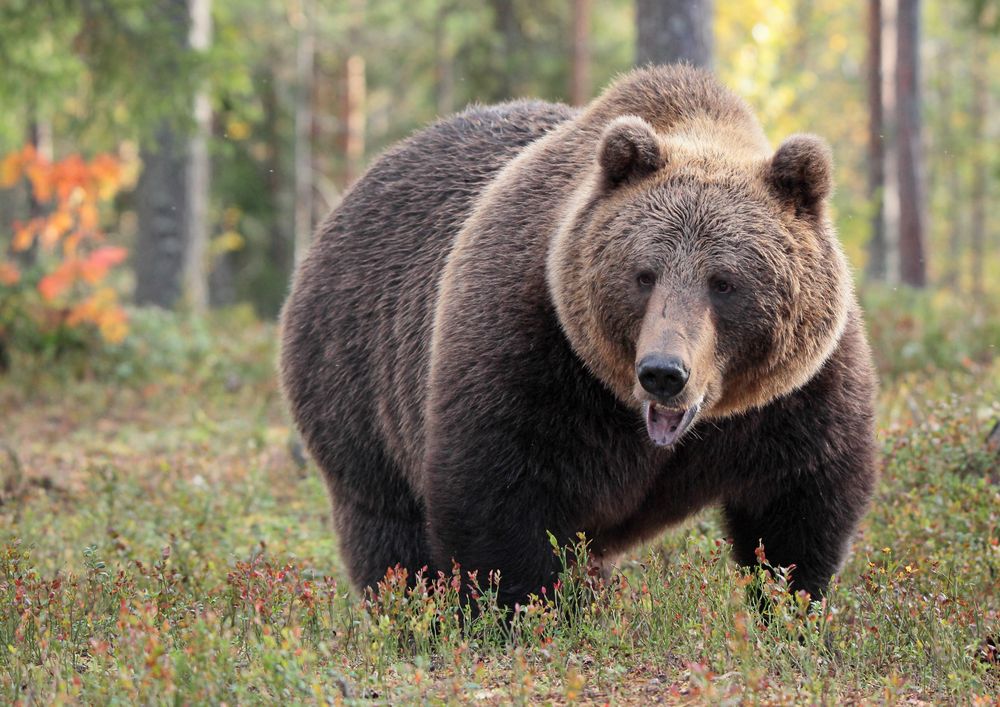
[868,0,888,280]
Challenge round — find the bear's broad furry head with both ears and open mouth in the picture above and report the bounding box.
[547,116,853,446]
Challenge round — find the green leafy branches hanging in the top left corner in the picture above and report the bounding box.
[0,0,201,152]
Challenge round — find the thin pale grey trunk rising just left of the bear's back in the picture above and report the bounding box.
[295,0,316,263]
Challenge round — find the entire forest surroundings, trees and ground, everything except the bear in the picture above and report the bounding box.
[0,0,1000,705]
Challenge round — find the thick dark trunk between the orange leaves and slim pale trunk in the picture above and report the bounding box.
[133,0,190,308]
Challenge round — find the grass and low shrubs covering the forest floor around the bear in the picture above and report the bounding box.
[0,293,1000,704]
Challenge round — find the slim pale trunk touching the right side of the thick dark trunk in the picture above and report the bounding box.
[184,0,212,312]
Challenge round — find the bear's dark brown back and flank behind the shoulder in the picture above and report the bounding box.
[281,101,575,485]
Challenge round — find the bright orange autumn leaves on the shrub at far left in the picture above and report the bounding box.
[0,145,128,342]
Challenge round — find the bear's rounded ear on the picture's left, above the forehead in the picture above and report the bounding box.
[597,115,666,188]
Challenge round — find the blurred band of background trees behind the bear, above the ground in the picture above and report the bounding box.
[0,0,1000,327]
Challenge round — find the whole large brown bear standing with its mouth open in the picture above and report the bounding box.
[281,67,876,602]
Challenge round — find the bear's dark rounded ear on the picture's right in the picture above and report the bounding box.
[767,135,833,217]
